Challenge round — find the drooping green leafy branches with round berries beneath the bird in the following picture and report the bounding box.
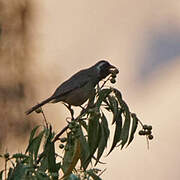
[0,74,153,180]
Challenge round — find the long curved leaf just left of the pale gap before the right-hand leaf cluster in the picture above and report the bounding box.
[95,113,110,165]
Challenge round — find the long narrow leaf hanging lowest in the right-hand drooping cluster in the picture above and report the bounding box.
[107,110,122,155]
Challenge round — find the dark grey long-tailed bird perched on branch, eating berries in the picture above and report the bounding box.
[25,60,117,115]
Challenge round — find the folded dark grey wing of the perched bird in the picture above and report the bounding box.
[52,69,91,98]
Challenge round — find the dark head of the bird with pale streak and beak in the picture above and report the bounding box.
[94,60,118,81]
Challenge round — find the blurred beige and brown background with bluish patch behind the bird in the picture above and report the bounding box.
[0,0,180,180]
